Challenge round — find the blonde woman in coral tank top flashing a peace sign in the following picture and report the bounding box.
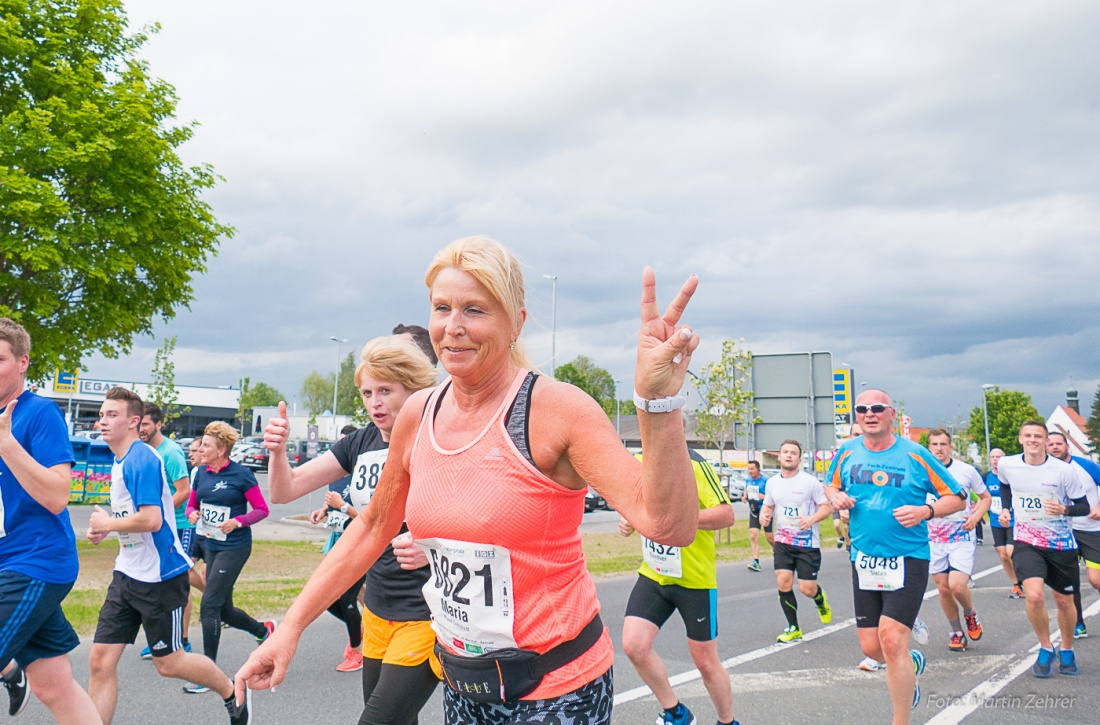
[237,237,699,724]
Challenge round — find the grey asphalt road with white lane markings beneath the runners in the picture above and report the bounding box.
[38,479,1100,725]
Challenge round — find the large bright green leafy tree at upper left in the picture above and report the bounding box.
[0,0,233,381]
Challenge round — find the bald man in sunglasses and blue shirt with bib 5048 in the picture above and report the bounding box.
[825,388,965,725]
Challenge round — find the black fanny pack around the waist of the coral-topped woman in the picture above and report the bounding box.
[436,613,604,704]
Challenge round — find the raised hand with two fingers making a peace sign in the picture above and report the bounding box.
[635,267,699,399]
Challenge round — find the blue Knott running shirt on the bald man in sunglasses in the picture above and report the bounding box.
[826,438,963,560]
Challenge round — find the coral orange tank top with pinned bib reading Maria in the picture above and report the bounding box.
[405,370,615,700]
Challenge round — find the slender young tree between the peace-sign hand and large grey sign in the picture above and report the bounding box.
[694,338,762,462]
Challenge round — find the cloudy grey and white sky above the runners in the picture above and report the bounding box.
[87,0,1100,425]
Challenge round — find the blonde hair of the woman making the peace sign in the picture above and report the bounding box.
[424,237,538,370]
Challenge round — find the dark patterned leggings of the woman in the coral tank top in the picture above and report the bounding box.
[443,669,615,725]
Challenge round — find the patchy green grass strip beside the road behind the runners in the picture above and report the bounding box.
[62,518,836,635]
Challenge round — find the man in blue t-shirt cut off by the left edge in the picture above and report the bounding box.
[0,318,99,723]
